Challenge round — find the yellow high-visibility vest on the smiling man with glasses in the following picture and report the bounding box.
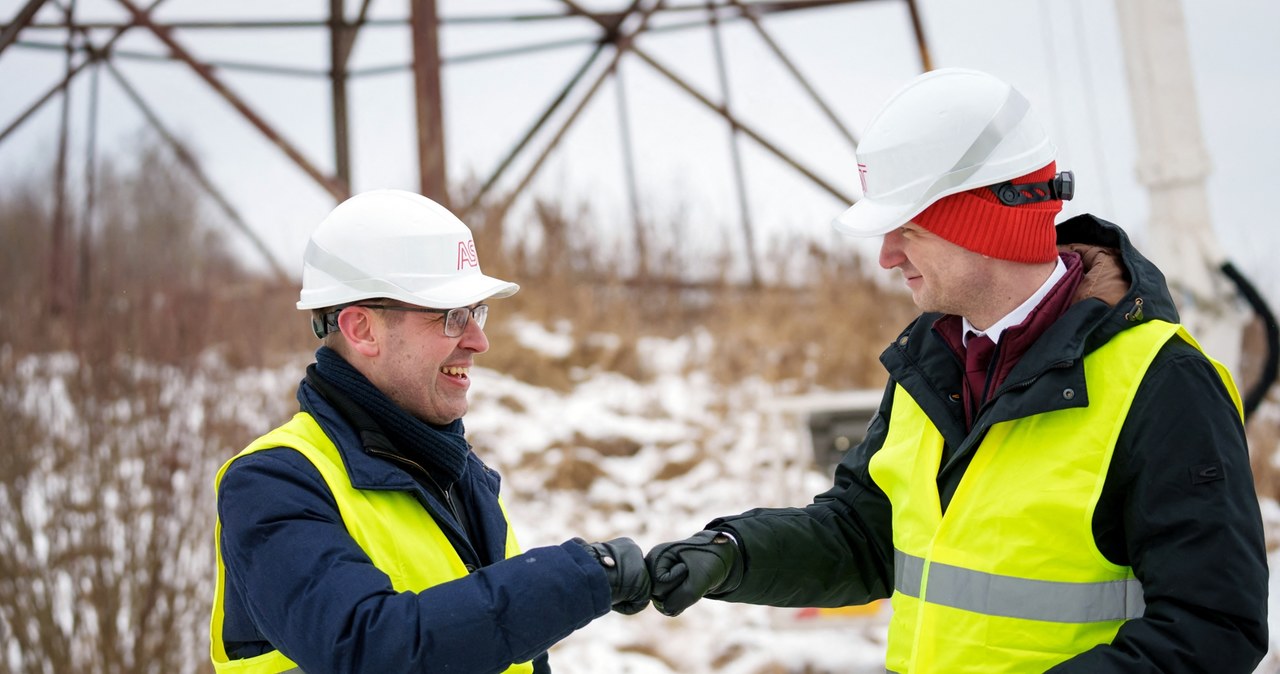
[209,412,534,674]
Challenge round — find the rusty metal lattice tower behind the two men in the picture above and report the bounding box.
[0,0,931,308]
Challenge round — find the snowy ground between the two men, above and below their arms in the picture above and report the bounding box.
[466,341,887,674]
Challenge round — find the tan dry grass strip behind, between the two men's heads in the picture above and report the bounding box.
[465,193,915,390]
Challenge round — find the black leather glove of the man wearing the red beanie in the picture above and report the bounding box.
[644,531,742,615]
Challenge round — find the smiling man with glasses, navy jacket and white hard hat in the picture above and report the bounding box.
[210,189,649,674]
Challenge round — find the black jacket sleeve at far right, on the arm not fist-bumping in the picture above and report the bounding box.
[1051,340,1268,674]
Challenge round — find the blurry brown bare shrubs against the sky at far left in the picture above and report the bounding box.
[0,146,315,366]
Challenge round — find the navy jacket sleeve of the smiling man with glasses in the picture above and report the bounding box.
[218,449,609,674]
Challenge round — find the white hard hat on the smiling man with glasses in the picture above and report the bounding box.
[298,189,520,310]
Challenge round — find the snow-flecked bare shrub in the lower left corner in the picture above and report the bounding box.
[0,354,221,671]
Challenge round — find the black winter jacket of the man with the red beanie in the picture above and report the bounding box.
[708,215,1267,674]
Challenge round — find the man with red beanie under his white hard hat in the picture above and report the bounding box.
[648,69,1267,674]
